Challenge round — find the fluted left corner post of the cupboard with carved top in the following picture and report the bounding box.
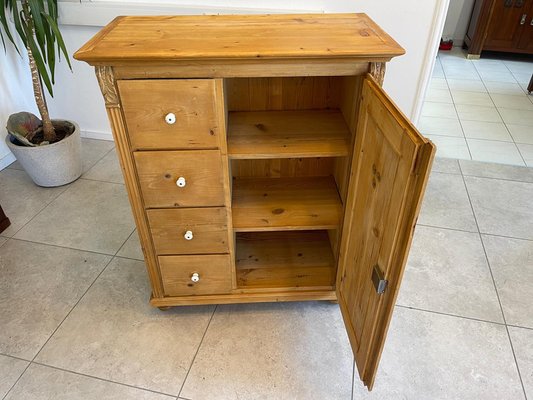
[96,67,163,298]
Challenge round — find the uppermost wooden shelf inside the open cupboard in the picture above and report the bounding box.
[228,110,350,159]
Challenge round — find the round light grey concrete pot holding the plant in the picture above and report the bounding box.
[6,121,82,187]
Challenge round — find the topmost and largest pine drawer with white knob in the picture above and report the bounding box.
[118,79,220,150]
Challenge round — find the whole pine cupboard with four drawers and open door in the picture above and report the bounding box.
[75,14,434,388]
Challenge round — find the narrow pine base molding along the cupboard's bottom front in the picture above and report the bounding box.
[150,290,337,309]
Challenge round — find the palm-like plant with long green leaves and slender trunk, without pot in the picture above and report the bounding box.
[0,0,72,143]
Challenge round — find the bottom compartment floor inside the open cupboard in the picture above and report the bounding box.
[236,231,336,289]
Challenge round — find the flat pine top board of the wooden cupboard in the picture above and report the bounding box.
[74,14,404,65]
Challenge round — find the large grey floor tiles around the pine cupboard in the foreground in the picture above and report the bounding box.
[0,139,533,400]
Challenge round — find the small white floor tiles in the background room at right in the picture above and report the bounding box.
[418,47,533,166]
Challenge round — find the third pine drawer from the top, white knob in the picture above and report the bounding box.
[147,208,229,255]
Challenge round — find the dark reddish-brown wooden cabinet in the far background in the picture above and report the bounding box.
[465,0,533,59]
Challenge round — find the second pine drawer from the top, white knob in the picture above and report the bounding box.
[134,150,224,208]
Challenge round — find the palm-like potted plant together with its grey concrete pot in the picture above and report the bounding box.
[0,0,82,186]
